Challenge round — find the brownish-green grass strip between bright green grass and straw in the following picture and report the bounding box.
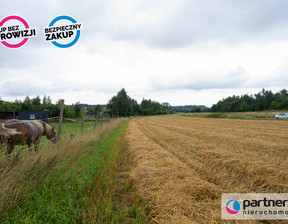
[83,123,151,224]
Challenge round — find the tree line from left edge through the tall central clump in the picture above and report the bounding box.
[0,89,174,118]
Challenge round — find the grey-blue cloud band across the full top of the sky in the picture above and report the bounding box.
[0,0,288,50]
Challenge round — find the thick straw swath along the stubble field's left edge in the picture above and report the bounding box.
[127,121,221,223]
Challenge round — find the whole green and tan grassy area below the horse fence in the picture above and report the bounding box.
[0,119,149,223]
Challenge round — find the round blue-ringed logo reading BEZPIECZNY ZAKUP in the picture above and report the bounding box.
[44,15,82,48]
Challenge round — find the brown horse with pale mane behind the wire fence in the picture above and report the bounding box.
[2,119,56,155]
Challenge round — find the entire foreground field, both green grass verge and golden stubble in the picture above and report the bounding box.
[0,115,288,224]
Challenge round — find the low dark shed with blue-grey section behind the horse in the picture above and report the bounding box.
[0,110,48,123]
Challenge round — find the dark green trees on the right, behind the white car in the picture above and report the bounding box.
[210,89,288,112]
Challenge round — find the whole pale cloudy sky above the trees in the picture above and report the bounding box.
[0,0,288,106]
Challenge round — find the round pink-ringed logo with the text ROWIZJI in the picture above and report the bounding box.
[0,15,36,48]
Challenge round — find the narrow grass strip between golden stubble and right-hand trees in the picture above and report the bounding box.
[179,111,284,120]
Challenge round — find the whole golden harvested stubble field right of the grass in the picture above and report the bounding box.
[126,115,288,223]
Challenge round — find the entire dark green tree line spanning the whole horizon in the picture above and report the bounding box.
[0,88,288,118]
